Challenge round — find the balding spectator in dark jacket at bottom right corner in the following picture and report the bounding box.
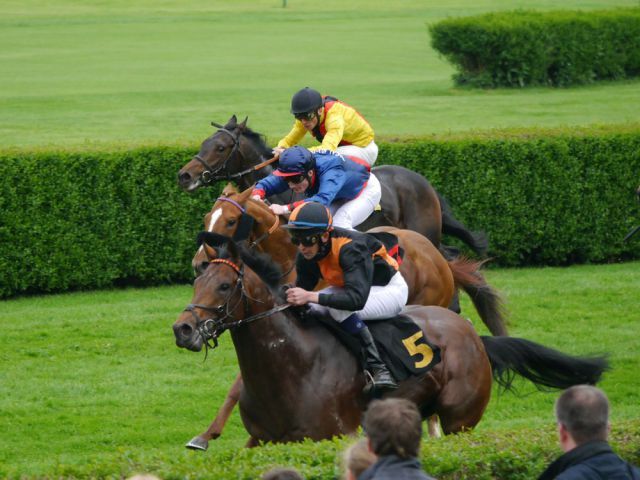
[538,385,640,480]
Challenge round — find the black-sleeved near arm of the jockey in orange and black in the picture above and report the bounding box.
[318,242,373,312]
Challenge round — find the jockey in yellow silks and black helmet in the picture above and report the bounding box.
[273,87,378,167]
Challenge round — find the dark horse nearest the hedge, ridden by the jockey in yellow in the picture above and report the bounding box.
[178,115,488,254]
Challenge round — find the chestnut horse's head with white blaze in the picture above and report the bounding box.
[191,185,279,275]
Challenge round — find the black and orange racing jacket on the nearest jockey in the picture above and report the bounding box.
[296,227,399,312]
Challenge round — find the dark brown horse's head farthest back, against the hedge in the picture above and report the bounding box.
[178,115,252,192]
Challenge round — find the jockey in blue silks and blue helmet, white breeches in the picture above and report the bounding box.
[251,146,382,229]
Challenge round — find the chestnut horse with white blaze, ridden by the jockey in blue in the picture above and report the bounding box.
[187,184,507,450]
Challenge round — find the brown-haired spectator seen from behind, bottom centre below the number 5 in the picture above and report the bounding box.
[358,398,434,480]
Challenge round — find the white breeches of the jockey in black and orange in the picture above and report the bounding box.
[311,272,409,322]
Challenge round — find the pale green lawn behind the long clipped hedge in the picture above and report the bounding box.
[0,0,640,149]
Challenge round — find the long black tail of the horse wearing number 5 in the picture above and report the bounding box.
[480,336,609,390]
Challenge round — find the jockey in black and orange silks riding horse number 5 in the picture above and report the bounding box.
[284,202,409,390]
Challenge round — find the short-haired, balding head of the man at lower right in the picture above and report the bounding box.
[556,385,609,452]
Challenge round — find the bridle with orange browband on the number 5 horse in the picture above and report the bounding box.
[184,258,291,360]
